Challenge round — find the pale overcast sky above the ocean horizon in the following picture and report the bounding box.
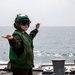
[0,0,75,26]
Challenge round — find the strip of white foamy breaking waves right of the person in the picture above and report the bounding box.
[34,50,75,57]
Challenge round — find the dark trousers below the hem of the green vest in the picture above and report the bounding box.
[11,68,33,75]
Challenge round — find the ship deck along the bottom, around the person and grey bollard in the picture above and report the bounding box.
[0,64,75,75]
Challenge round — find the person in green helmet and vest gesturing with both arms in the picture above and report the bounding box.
[2,14,40,75]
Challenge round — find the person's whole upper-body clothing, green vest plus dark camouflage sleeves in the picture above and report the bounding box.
[9,29,38,69]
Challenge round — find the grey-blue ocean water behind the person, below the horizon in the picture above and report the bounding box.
[0,26,75,66]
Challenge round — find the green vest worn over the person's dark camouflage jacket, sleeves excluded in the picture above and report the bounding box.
[9,30,34,68]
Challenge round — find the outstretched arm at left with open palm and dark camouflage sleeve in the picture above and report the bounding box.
[2,34,22,50]
